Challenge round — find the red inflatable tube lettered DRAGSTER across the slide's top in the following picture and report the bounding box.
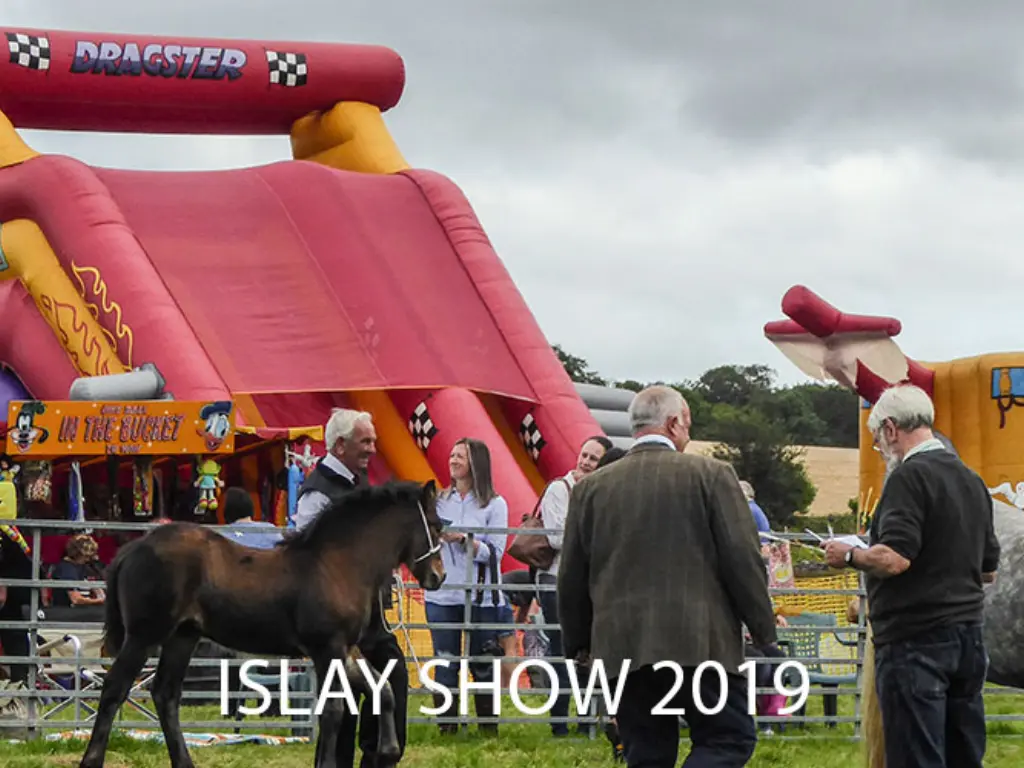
[0,29,406,135]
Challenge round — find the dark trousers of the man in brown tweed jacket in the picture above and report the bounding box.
[611,667,758,768]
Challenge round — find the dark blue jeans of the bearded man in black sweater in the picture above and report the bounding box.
[874,624,988,768]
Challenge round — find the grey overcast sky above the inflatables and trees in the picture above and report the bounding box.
[3,0,1024,391]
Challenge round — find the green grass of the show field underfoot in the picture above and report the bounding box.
[0,695,1024,768]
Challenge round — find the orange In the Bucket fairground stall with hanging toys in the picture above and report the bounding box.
[0,374,323,564]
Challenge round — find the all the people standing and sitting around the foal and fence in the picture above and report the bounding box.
[0,385,1000,768]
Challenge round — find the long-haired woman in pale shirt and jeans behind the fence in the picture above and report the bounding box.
[424,437,509,733]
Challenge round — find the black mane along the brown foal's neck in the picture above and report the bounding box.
[276,480,422,549]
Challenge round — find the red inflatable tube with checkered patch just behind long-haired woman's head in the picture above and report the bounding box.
[390,388,537,571]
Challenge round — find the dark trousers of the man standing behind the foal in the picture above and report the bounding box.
[335,629,409,768]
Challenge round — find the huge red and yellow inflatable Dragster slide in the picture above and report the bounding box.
[0,29,600,566]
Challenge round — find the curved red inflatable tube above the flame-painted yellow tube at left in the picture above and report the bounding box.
[0,156,230,400]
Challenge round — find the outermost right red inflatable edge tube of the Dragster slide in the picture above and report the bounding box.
[402,170,603,480]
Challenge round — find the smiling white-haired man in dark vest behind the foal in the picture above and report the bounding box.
[295,409,409,768]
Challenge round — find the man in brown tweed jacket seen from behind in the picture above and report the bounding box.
[558,386,781,768]
